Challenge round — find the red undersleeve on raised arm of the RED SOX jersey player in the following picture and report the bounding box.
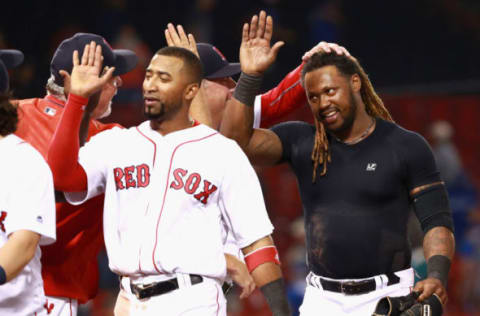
[47,94,88,192]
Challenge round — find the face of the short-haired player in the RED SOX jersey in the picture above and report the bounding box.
[143,55,188,119]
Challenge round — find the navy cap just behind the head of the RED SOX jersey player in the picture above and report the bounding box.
[197,43,241,79]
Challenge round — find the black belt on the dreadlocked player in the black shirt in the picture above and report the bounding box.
[320,273,400,295]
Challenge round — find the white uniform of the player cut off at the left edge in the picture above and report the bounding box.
[0,135,56,315]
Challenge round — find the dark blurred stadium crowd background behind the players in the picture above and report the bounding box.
[0,0,480,316]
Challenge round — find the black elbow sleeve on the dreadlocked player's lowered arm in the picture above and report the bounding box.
[413,184,453,233]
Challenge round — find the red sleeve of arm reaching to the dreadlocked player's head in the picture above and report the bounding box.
[260,63,307,127]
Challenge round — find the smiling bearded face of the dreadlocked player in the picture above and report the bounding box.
[304,66,360,134]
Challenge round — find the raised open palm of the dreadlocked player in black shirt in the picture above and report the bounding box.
[240,11,285,76]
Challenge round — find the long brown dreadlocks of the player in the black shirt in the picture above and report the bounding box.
[302,52,393,182]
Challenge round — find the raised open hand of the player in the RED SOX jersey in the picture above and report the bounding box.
[60,41,115,98]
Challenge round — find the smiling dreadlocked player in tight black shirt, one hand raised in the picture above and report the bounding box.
[221,11,454,315]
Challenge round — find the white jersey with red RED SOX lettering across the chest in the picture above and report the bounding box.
[66,121,273,280]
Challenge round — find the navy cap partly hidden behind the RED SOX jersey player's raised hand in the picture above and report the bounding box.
[50,33,138,86]
